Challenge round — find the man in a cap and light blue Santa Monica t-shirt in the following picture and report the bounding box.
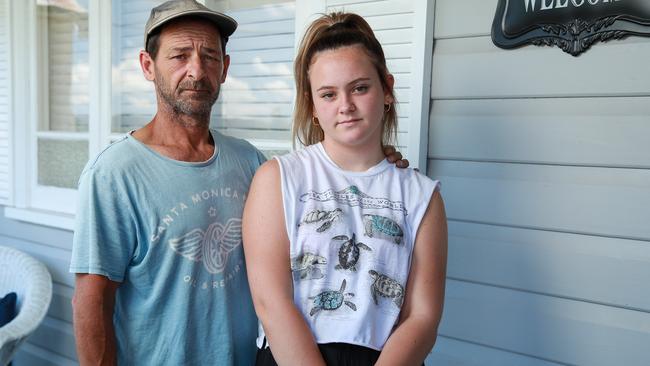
[70,0,404,365]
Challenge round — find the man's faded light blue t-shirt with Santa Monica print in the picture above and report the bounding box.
[70,131,265,365]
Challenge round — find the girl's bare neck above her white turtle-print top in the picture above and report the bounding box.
[322,139,386,172]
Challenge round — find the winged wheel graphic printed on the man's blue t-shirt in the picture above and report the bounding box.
[169,219,241,273]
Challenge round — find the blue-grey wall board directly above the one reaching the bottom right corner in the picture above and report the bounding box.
[443,220,650,313]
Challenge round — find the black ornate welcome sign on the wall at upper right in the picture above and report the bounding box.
[492,0,650,56]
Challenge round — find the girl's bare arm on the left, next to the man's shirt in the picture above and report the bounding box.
[242,160,325,365]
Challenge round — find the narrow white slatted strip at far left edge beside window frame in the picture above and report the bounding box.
[0,0,12,204]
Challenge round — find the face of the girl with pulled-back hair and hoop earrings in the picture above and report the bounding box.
[309,45,394,149]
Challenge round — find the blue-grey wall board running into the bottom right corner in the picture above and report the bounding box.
[440,280,650,366]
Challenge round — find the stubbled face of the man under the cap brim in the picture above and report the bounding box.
[153,19,230,120]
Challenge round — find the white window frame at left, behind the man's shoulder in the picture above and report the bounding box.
[5,0,109,229]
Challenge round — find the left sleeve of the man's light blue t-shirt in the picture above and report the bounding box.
[70,167,137,282]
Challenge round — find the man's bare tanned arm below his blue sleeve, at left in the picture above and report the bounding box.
[72,273,120,365]
